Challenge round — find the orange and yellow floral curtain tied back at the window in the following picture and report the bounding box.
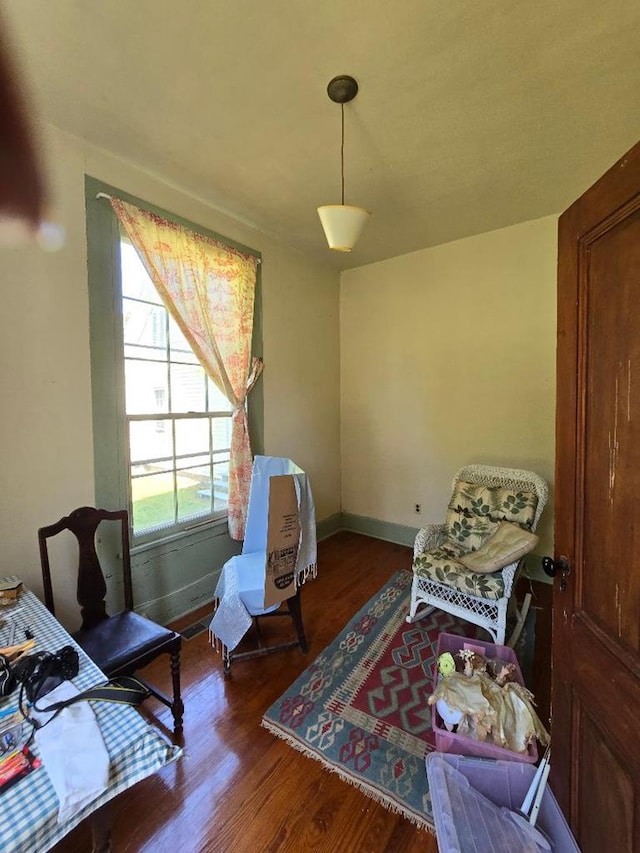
[111,198,263,540]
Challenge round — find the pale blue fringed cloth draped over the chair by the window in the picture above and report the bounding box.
[209,456,317,651]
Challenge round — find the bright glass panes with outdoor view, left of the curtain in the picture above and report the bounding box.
[120,239,232,535]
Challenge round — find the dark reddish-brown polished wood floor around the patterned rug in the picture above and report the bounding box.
[54,533,549,853]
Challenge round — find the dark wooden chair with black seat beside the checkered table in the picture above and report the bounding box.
[38,506,184,736]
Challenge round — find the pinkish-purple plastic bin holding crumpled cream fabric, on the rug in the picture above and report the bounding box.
[431,634,538,764]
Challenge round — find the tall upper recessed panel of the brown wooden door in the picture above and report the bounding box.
[580,211,640,655]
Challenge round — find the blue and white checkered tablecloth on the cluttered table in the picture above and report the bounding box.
[0,578,182,853]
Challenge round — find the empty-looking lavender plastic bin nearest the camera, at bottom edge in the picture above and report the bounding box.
[426,752,580,853]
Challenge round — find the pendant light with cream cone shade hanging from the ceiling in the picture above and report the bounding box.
[318,74,371,252]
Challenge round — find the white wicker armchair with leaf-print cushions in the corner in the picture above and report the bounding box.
[407,465,548,645]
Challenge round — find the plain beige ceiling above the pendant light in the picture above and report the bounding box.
[1,0,640,269]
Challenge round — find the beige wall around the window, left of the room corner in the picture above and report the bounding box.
[0,121,340,591]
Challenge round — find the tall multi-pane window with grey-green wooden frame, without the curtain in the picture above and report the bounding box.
[86,177,263,556]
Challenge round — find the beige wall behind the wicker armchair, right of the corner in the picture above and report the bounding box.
[340,216,557,553]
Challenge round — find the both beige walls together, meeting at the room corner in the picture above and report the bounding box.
[0,120,556,608]
